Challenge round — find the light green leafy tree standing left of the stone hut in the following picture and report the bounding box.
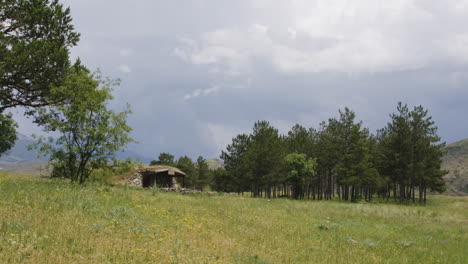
[33,64,133,183]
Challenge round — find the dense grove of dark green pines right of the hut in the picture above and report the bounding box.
[211,103,447,203]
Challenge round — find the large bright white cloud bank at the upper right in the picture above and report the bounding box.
[175,0,468,73]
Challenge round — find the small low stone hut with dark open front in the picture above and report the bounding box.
[127,165,185,189]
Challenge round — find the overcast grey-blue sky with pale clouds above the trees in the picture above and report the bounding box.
[12,0,468,160]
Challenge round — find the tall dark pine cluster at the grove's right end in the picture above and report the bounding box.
[379,103,447,203]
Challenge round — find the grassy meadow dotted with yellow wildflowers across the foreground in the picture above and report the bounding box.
[0,174,468,263]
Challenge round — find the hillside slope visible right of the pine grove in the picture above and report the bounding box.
[442,138,468,195]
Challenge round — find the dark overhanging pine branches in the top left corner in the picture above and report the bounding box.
[0,0,79,111]
